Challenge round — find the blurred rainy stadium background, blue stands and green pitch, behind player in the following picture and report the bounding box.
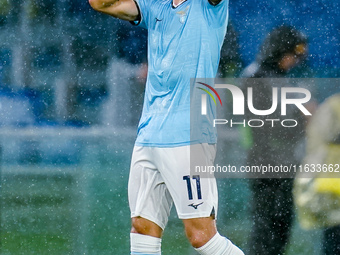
[0,0,340,255]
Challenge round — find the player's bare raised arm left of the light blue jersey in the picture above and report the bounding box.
[89,0,139,21]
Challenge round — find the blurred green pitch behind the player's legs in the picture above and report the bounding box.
[0,138,320,255]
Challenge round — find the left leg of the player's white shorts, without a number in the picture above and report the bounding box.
[128,146,173,230]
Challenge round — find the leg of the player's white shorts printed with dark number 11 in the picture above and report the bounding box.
[157,144,218,219]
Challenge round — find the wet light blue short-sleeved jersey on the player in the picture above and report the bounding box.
[136,0,228,147]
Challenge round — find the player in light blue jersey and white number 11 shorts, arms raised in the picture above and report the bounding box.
[89,0,243,255]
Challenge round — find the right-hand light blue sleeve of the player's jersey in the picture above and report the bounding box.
[202,0,229,28]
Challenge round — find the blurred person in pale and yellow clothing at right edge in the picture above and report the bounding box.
[294,93,340,255]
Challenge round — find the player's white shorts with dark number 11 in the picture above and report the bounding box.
[128,144,218,229]
